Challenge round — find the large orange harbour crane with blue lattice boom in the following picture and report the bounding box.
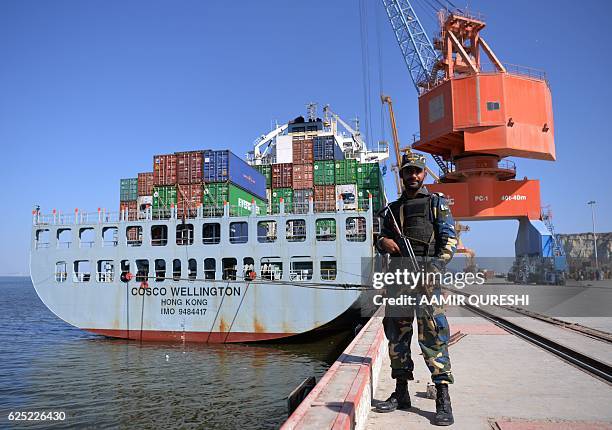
[382,0,555,268]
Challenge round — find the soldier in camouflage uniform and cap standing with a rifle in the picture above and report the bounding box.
[377,154,457,425]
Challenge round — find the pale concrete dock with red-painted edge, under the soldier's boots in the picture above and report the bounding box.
[282,306,612,430]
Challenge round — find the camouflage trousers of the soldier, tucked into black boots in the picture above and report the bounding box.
[383,290,453,384]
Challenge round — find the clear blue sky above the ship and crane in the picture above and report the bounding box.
[0,0,612,274]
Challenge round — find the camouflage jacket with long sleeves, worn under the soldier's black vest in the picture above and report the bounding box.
[376,186,457,268]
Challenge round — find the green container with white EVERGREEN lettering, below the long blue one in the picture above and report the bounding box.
[202,182,267,216]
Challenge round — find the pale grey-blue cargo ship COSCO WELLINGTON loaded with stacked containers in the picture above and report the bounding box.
[30,108,388,343]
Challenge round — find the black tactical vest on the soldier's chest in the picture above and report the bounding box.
[400,196,436,257]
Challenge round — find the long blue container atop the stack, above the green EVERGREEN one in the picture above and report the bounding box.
[203,149,266,200]
